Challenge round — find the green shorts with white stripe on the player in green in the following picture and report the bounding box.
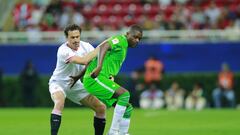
[83,76,120,107]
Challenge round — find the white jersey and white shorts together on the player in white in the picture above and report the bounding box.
[49,41,94,104]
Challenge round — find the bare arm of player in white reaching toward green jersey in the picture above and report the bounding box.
[68,46,100,65]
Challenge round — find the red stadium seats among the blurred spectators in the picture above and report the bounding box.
[7,0,240,31]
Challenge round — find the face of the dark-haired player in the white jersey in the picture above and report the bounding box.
[67,30,80,50]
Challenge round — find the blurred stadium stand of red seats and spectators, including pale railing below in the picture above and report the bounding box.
[0,0,240,43]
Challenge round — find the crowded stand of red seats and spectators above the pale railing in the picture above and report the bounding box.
[1,0,240,31]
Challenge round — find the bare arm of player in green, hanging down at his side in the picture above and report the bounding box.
[91,40,111,78]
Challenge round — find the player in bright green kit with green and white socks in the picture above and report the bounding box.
[83,25,143,135]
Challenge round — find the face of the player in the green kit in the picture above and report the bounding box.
[127,31,142,47]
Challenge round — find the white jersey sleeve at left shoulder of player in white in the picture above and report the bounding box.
[58,48,76,63]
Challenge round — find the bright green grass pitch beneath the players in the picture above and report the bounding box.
[0,108,240,135]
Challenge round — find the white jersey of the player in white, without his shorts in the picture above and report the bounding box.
[49,41,94,83]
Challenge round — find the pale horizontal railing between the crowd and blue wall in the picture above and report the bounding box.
[0,28,240,44]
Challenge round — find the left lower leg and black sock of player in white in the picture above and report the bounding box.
[50,91,65,135]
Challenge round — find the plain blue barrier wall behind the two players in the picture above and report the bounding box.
[0,42,240,74]
